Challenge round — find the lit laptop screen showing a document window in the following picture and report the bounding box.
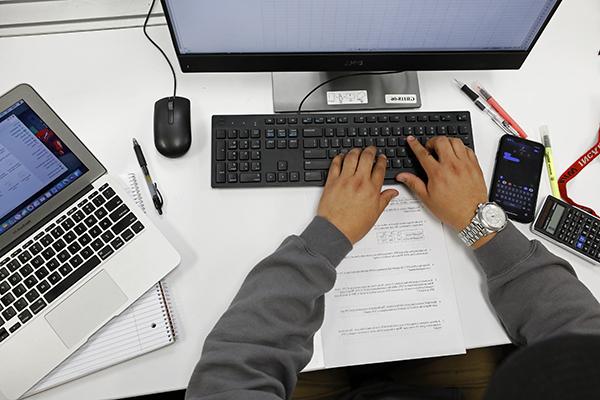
[0,100,88,235]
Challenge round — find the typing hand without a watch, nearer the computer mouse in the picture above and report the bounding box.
[317,146,398,245]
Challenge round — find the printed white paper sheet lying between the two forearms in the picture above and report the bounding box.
[307,187,465,369]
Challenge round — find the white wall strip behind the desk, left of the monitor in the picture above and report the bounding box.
[0,0,165,37]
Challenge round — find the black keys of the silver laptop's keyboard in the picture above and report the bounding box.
[0,183,144,342]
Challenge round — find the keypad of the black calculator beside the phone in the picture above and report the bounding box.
[558,208,600,261]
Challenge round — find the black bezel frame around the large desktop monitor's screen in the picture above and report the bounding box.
[161,0,562,72]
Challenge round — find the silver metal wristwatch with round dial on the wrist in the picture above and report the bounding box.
[458,202,508,247]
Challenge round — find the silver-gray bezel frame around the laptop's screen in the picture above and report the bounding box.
[0,83,106,255]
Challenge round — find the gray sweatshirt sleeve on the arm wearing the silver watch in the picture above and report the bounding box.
[475,224,600,344]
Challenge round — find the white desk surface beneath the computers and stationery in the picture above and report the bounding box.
[0,0,600,399]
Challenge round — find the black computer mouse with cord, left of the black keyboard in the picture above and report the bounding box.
[154,97,192,158]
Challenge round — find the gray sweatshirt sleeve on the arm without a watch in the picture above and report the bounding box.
[186,217,352,400]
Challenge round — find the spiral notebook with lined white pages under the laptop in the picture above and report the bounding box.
[24,173,176,397]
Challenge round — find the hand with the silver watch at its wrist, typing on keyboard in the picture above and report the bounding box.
[396,136,488,232]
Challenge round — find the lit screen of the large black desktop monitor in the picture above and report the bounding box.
[163,0,558,55]
